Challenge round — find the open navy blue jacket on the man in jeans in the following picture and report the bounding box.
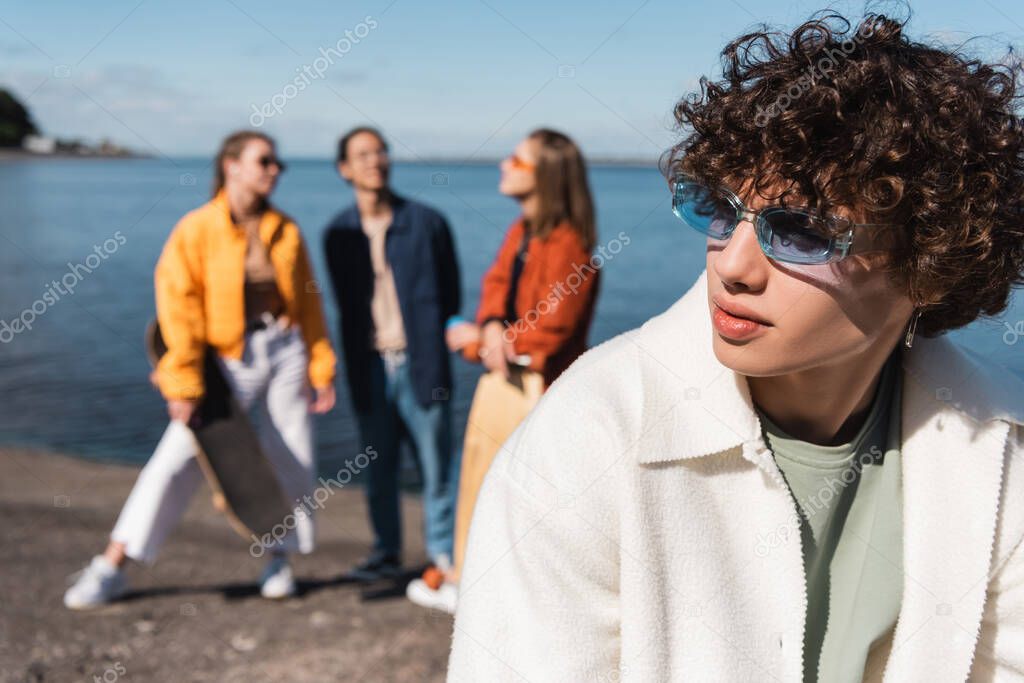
[324,197,461,413]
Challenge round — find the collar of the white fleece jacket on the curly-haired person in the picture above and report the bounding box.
[629,270,1024,463]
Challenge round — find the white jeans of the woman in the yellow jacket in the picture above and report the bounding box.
[111,324,316,563]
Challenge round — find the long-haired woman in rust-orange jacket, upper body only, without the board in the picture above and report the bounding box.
[447,129,599,386]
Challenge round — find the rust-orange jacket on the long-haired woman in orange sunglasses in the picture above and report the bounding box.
[463,218,600,386]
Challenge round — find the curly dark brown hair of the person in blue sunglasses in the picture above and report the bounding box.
[664,6,1024,336]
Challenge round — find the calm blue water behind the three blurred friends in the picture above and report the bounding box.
[0,160,1024,472]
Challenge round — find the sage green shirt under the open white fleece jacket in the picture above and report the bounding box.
[758,349,903,683]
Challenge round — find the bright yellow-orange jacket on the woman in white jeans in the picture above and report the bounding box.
[155,190,335,400]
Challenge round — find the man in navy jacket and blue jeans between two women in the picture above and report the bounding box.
[325,127,460,581]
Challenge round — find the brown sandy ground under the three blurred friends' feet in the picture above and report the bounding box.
[0,449,452,683]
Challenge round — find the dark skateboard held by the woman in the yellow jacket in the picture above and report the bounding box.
[145,321,294,541]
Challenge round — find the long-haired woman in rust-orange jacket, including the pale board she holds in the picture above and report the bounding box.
[407,129,600,612]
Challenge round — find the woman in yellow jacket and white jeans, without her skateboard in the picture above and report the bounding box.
[65,131,335,609]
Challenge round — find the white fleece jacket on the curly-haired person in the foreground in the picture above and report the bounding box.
[449,273,1024,683]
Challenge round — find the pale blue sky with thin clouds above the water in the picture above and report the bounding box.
[0,0,1024,159]
